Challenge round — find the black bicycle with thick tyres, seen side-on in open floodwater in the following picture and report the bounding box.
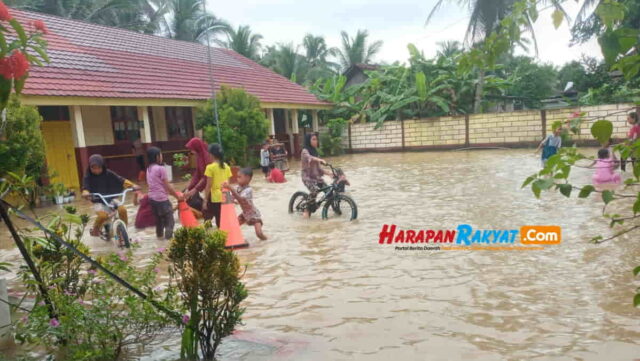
[289,163,358,221]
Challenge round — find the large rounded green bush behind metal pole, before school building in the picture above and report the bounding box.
[196,86,268,165]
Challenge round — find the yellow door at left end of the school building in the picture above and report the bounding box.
[41,121,80,191]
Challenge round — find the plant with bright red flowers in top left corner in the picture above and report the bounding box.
[0,1,49,111]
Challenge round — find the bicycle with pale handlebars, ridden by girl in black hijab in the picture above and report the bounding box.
[89,188,134,248]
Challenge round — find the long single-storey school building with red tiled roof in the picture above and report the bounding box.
[12,10,331,189]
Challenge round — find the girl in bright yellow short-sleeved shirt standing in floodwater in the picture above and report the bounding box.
[202,144,231,228]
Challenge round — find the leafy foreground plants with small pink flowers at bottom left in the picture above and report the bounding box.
[15,207,175,360]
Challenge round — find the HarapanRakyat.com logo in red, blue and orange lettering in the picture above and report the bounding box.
[378,224,562,251]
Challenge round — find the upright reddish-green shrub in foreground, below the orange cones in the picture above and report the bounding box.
[168,227,247,360]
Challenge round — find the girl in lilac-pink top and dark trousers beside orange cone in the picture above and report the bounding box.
[147,147,184,240]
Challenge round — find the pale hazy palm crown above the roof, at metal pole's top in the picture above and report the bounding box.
[168,0,229,42]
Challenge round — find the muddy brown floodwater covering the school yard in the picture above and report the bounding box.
[0,150,640,360]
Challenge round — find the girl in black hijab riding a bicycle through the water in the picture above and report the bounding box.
[82,154,138,237]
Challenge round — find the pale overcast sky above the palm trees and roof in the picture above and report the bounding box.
[207,0,601,66]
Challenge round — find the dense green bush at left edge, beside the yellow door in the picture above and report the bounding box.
[0,97,45,179]
